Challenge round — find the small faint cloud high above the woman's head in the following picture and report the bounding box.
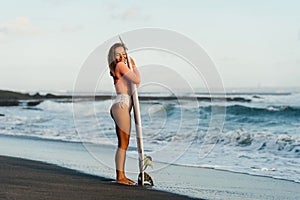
[110,8,150,21]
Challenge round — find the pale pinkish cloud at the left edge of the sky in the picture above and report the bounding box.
[0,17,39,35]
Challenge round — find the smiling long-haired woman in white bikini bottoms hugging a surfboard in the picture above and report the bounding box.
[108,43,140,185]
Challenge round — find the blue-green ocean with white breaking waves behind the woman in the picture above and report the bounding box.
[0,90,300,183]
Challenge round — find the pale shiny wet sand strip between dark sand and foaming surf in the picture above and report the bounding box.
[0,135,300,200]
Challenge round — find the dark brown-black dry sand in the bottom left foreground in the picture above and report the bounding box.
[0,156,199,200]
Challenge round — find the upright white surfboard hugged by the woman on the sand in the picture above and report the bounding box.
[119,36,145,186]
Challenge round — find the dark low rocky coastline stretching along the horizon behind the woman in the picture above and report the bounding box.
[0,86,292,107]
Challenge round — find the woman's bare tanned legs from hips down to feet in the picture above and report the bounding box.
[111,103,136,185]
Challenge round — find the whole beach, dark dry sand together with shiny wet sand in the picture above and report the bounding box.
[0,136,300,200]
